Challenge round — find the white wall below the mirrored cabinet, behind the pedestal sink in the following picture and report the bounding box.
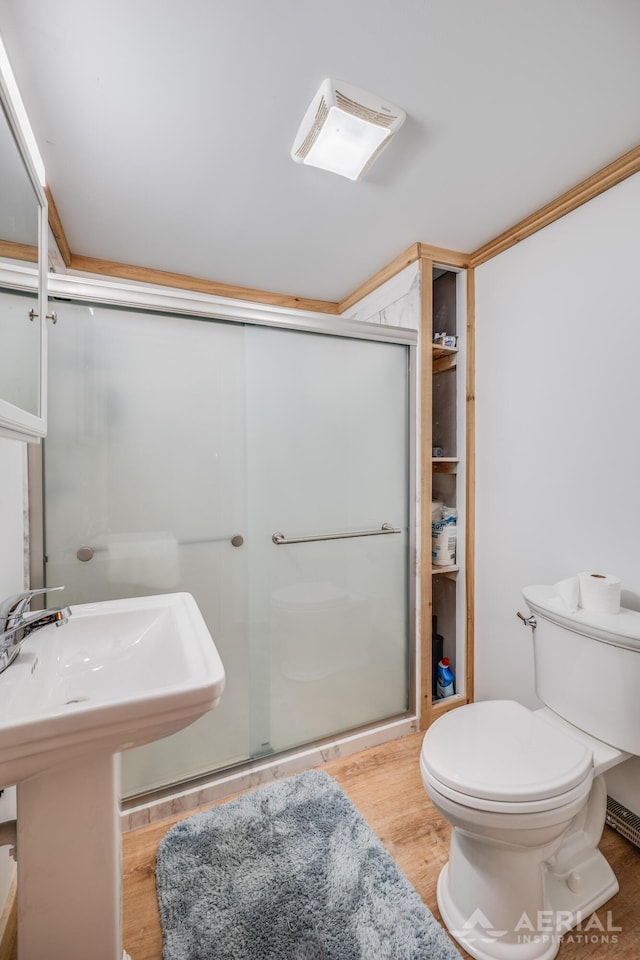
[0,437,26,911]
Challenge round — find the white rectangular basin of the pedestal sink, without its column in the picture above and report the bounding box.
[0,593,225,787]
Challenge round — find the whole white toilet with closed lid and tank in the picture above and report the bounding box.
[420,586,640,960]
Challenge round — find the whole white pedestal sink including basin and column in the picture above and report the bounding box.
[0,593,225,960]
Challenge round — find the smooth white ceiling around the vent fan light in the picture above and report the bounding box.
[0,0,640,300]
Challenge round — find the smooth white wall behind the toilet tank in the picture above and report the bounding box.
[475,174,640,706]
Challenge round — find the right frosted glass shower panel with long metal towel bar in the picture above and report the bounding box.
[247,328,408,753]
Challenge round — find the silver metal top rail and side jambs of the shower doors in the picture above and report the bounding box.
[28,266,420,732]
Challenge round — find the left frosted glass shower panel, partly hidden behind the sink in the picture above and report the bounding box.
[45,304,249,795]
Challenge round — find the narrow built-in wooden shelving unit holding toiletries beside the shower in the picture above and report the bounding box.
[421,261,473,729]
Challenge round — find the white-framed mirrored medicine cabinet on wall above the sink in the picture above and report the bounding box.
[0,56,48,440]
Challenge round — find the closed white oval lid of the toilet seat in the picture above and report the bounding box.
[422,700,592,802]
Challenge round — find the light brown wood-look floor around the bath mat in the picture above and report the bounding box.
[123,734,640,960]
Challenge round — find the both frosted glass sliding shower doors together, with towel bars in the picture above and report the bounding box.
[37,294,414,797]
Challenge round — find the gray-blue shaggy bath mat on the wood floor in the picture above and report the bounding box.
[156,770,460,960]
